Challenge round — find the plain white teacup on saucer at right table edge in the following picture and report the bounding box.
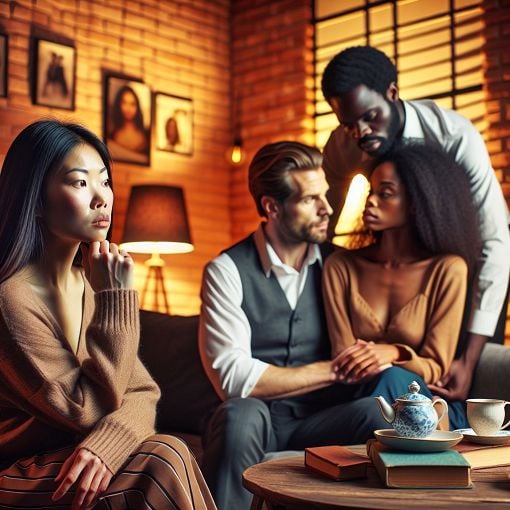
[466,398,510,436]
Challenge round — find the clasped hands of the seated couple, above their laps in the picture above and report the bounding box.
[332,338,399,384]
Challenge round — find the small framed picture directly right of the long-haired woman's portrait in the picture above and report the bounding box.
[154,92,193,155]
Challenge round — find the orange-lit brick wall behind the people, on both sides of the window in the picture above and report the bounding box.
[0,0,510,332]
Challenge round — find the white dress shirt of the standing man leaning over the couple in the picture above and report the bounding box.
[323,100,510,337]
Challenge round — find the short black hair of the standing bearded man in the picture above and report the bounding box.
[322,46,397,101]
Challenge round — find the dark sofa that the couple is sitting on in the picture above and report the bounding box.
[140,310,510,460]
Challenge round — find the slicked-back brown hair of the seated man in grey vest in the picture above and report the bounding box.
[248,141,322,216]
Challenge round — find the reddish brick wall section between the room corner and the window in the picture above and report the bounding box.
[231,0,314,240]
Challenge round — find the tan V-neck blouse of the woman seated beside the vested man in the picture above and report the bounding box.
[323,251,467,383]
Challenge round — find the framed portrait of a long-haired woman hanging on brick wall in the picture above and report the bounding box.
[103,76,151,166]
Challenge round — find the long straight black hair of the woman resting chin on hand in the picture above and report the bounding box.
[0,120,111,282]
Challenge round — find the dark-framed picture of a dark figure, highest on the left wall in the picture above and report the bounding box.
[33,39,76,110]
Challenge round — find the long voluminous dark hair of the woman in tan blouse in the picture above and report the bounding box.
[373,141,481,275]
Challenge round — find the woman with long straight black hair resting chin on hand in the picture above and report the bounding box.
[0,120,214,510]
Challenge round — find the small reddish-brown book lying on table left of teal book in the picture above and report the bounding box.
[305,445,371,480]
